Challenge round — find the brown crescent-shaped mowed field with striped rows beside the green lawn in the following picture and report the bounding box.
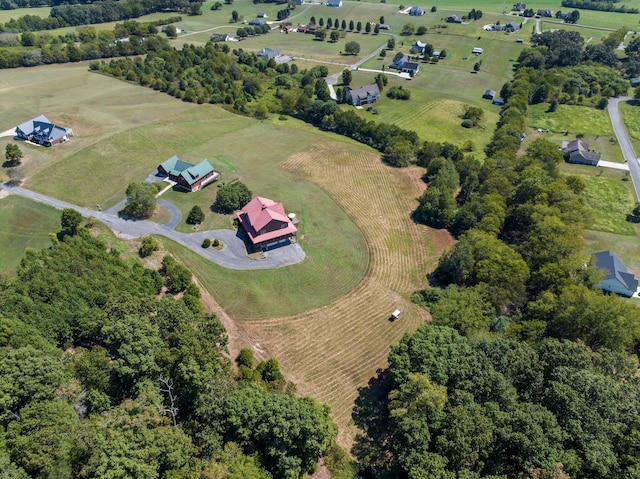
[230,142,453,447]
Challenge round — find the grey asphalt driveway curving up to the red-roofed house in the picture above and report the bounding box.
[3,184,305,270]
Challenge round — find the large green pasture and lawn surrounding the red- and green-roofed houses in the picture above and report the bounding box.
[0,64,368,318]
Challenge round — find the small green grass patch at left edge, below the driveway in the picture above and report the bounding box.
[0,195,60,271]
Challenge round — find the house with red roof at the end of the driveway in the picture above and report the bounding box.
[237,196,298,251]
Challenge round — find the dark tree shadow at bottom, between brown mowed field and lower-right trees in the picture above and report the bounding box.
[351,369,392,477]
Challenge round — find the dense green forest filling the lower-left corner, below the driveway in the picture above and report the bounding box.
[0,222,336,479]
